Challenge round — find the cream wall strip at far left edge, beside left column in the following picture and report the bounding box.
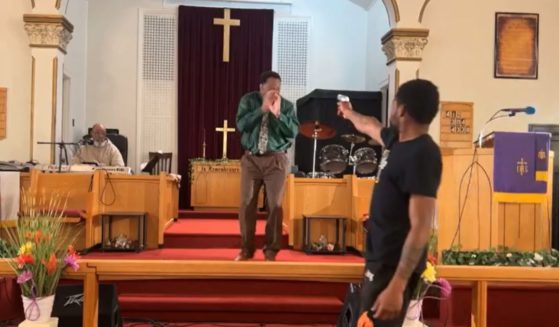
[0,0,31,161]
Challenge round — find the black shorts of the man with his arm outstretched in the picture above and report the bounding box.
[361,262,420,327]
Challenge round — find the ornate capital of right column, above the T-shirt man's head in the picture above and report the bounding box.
[382,28,429,104]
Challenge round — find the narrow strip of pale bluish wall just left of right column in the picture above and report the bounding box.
[366,0,390,91]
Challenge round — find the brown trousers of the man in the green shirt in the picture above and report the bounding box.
[239,152,289,257]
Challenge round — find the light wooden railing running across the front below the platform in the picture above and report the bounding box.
[0,259,559,327]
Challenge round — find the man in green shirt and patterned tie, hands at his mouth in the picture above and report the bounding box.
[235,71,299,261]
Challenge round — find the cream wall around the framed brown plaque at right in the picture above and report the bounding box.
[420,0,559,144]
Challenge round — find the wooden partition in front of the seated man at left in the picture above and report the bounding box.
[21,170,178,248]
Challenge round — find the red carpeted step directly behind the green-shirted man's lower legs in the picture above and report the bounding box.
[163,219,288,249]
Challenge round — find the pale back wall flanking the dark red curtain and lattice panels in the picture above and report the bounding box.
[86,0,372,167]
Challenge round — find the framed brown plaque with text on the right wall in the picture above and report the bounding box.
[494,12,539,79]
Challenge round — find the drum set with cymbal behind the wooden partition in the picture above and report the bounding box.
[299,121,378,178]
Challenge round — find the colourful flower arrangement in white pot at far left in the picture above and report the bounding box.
[1,193,79,322]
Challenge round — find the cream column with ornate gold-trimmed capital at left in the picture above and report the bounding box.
[23,0,74,163]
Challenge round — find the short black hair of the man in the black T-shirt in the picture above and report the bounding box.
[396,79,439,124]
